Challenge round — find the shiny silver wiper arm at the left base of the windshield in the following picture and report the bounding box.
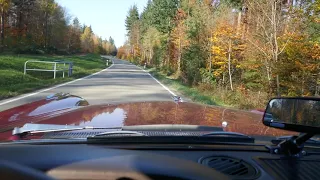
[12,123,122,138]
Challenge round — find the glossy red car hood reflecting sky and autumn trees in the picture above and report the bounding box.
[0,93,292,140]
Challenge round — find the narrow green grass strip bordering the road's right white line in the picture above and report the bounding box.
[148,68,228,106]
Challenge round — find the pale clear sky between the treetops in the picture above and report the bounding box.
[56,0,148,47]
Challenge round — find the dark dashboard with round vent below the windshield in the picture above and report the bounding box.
[0,144,320,180]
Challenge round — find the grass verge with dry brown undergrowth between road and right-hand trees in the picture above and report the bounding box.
[144,68,267,110]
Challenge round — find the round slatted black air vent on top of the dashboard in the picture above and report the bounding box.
[200,156,259,179]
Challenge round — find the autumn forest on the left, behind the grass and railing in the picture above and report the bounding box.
[0,0,117,55]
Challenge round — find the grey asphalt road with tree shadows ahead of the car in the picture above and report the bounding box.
[0,59,176,111]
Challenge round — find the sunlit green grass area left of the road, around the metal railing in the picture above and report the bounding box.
[0,54,106,99]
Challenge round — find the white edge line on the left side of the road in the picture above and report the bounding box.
[0,63,114,106]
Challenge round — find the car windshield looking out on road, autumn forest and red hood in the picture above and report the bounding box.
[0,0,320,139]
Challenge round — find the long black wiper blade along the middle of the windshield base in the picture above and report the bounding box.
[87,128,254,143]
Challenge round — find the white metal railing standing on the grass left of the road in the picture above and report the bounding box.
[24,60,73,79]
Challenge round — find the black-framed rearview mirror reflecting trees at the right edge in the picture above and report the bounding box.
[263,98,320,134]
